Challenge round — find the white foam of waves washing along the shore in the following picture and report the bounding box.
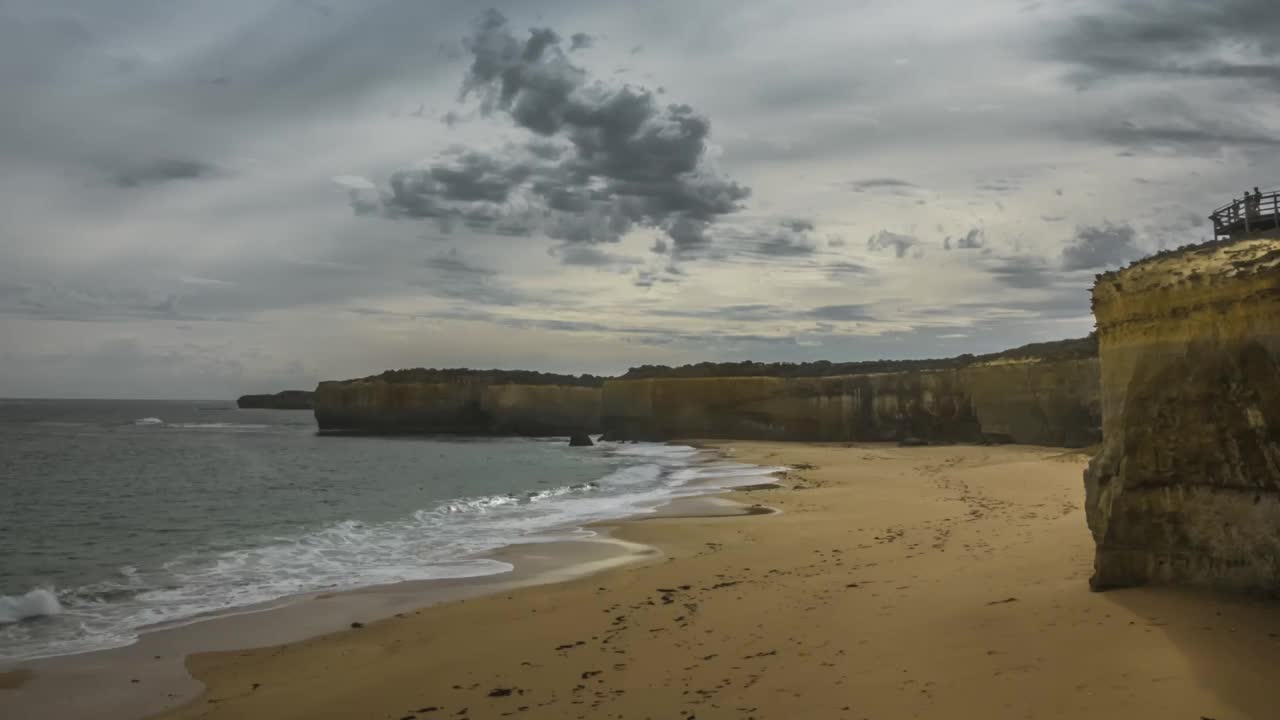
[0,440,780,660]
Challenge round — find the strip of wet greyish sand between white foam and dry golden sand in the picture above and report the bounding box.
[0,448,771,720]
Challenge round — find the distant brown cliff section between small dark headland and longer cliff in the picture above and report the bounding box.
[316,369,602,436]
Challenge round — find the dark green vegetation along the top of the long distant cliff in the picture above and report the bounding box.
[622,333,1098,379]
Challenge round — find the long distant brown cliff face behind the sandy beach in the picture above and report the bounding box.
[603,359,1100,447]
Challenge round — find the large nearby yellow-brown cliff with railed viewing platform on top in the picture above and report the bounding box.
[1085,240,1280,592]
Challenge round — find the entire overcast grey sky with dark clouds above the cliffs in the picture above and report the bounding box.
[0,0,1280,398]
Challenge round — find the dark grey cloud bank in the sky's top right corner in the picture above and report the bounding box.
[1052,0,1280,90]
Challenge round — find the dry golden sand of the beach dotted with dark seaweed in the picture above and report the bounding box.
[12,442,1280,720]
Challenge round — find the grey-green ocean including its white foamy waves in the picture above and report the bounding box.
[0,400,777,661]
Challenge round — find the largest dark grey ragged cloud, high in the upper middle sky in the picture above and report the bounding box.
[366,10,750,252]
